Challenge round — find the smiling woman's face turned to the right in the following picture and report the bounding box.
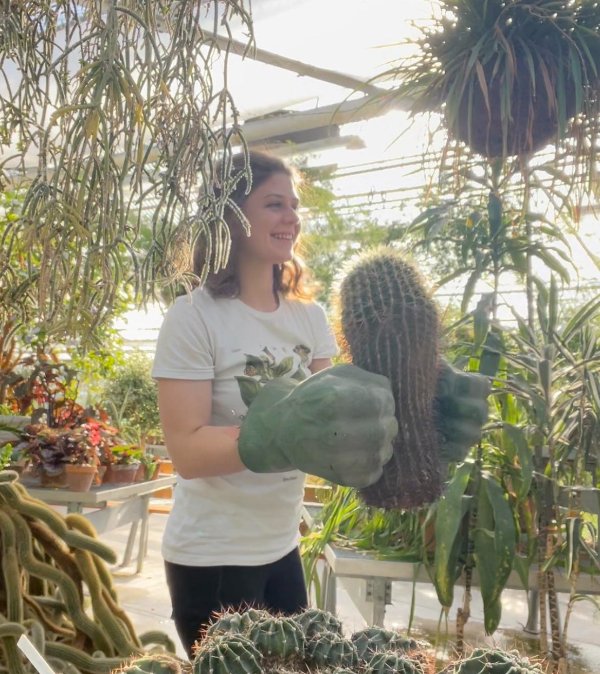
[240,173,300,265]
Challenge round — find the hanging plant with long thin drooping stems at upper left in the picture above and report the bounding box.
[0,0,252,337]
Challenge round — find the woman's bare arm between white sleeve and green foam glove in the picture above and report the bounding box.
[158,379,245,479]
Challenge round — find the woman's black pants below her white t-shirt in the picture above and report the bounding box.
[165,549,308,657]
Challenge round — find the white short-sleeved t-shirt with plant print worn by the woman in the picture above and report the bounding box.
[152,289,337,566]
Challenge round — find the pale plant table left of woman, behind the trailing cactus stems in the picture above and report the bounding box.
[27,475,177,573]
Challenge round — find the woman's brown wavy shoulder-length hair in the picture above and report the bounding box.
[194,150,313,300]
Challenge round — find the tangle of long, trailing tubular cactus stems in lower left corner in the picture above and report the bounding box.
[0,471,175,674]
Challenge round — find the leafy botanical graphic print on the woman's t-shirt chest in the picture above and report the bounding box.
[236,344,310,407]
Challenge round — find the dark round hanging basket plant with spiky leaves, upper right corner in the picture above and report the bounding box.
[393,0,600,158]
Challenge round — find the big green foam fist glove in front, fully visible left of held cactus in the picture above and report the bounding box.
[238,365,398,488]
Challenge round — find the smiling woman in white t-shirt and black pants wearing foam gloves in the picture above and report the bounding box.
[153,148,397,655]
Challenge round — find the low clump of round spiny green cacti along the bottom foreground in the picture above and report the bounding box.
[113,609,542,674]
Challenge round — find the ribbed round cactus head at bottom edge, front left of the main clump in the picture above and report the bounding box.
[192,634,263,674]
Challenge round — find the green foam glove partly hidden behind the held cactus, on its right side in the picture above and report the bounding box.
[435,360,490,463]
